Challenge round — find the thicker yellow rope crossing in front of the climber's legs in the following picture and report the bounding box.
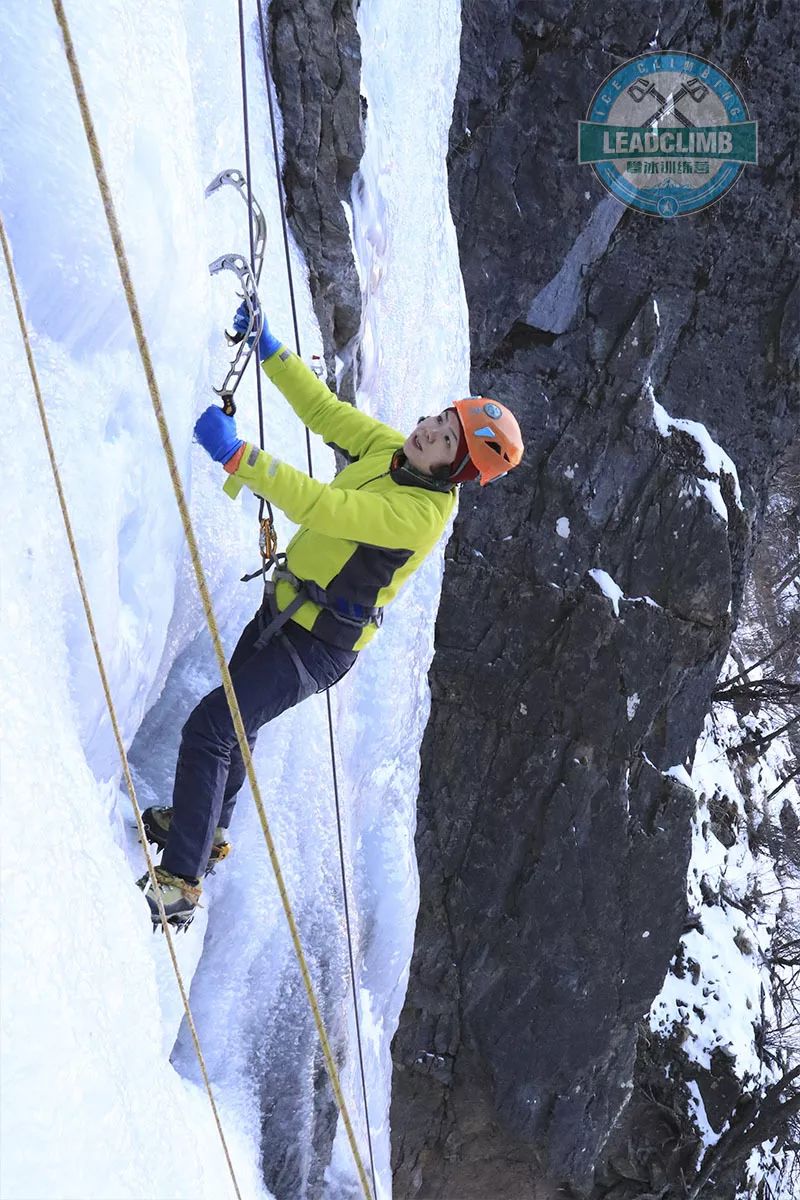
[53,0,372,1200]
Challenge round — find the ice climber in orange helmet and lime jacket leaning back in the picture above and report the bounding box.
[139,307,523,926]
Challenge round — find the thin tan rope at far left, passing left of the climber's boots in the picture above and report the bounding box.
[0,216,241,1200]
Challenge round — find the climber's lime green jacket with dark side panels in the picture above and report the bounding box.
[224,347,456,650]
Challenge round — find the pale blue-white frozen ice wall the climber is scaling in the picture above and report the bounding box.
[0,0,469,1200]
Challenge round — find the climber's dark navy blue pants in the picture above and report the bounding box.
[162,613,356,878]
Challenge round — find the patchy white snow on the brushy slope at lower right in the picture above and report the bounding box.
[649,676,800,1200]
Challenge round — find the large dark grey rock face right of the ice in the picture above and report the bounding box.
[392,0,800,1200]
